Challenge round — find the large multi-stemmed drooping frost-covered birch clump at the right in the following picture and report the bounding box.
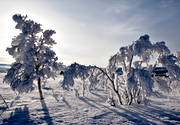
[107,35,180,104]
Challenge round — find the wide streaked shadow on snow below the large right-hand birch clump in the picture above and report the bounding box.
[106,105,180,125]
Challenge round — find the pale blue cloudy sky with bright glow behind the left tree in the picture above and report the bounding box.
[0,0,180,66]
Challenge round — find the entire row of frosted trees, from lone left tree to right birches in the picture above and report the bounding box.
[4,14,180,105]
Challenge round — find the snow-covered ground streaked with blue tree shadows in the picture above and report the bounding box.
[0,73,180,125]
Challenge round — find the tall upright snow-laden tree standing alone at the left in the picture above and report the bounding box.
[4,14,59,99]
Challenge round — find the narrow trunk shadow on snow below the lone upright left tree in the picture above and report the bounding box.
[41,100,54,125]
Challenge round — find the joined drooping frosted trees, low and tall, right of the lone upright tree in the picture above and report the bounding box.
[62,35,180,105]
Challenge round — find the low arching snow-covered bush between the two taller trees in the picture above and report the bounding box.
[60,63,108,96]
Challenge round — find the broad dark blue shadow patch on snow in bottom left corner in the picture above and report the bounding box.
[3,105,34,125]
